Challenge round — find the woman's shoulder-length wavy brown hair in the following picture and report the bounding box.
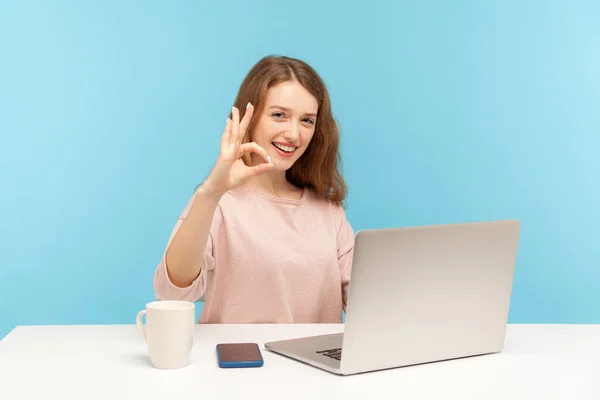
[234,55,348,206]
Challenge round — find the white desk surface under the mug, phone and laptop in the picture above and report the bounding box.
[0,325,600,400]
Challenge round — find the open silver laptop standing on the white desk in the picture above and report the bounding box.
[265,220,520,375]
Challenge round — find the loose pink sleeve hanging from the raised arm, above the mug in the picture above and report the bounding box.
[154,196,221,302]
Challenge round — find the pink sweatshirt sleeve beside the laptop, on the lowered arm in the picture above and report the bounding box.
[334,206,354,311]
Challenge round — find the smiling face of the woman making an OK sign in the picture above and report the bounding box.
[250,81,319,171]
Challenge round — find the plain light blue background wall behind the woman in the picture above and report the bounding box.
[0,0,600,337]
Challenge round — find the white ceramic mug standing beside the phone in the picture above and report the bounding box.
[136,300,196,369]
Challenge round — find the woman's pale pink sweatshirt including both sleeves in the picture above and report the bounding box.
[154,186,354,323]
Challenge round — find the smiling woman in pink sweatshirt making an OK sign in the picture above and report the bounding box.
[154,56,354,323]
